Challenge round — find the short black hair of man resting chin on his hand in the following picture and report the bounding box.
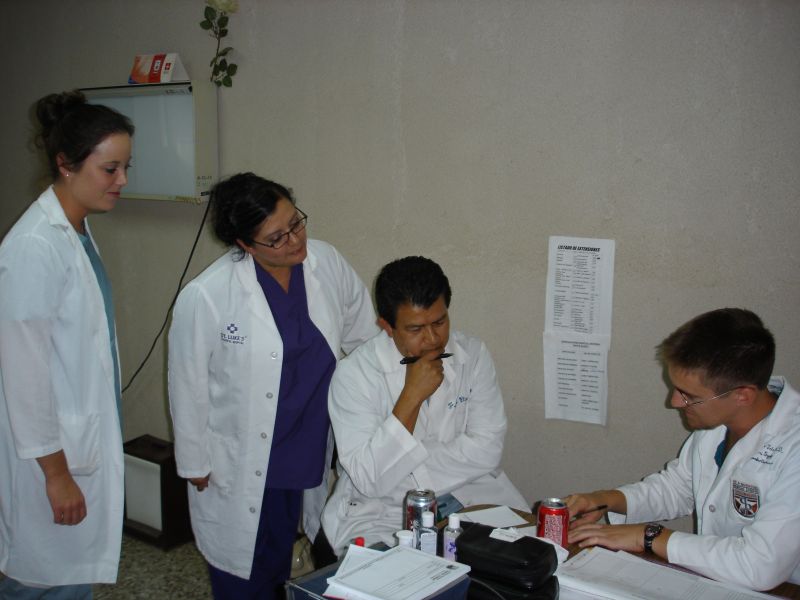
[375,256,452,327]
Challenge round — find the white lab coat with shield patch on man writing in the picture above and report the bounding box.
[609,377,800,590]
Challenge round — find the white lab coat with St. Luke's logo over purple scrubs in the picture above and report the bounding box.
[169,240,378,579]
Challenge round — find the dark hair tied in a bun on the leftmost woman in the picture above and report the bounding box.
[35,90,134,180]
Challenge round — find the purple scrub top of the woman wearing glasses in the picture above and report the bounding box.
[254,261,336,490]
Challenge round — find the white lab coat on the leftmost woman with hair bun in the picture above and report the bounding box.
[0,188,123,586]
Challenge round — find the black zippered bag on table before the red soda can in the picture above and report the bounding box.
[456,523,558,598]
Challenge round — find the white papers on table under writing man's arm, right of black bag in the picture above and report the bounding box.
[556,547,773,600]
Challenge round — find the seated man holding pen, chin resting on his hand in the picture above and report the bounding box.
[315,256,528,566]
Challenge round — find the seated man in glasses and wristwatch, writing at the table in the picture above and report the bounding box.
[567,308,800,590]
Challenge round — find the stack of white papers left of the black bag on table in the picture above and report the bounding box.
[325,546,470,600]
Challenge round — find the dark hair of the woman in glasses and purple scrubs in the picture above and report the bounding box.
[209,173,295,258]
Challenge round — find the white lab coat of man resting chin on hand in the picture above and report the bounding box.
[322,331,530,553]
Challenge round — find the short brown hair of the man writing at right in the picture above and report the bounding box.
[656,308,775,393]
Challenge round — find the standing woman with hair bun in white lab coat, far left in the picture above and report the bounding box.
[0,92,134,600]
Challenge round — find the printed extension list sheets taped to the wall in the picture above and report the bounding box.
[542,236,615,425]
